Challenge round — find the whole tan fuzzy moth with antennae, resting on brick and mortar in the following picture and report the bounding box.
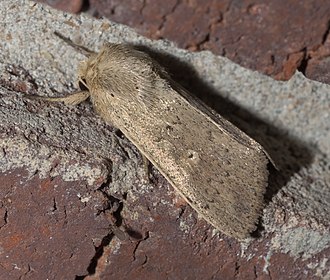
[29,34,268,239]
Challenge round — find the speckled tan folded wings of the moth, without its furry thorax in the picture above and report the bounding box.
[115,83,268,239]
